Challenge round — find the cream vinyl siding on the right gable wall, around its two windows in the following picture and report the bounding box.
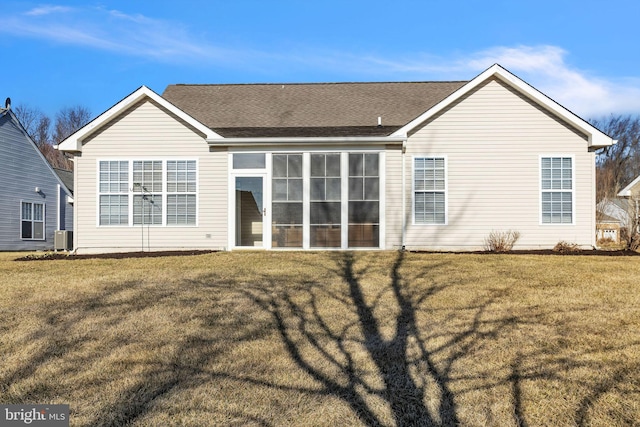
[400,80,595,250]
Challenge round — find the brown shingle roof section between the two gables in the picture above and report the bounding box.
[162,82,466,137]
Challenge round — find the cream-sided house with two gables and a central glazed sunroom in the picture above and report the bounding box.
[58,64,614,253]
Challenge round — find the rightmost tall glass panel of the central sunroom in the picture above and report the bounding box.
[348,153,380,247]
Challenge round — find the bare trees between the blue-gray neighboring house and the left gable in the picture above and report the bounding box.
[13,105,91,170]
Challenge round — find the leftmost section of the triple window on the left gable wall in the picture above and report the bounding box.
[98,161,129,225]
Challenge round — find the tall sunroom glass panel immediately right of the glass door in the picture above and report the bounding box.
[271,154,302,247]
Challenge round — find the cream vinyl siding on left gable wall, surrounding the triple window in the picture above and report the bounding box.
[74,101,229,253]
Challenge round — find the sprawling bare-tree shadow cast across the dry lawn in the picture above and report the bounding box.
[0,252,640,426]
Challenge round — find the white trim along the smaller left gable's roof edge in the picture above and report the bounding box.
[55,86,222,152]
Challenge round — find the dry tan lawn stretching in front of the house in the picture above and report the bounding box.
[0,252,640,426]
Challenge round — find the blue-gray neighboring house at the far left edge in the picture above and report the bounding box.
[0,103,73,251]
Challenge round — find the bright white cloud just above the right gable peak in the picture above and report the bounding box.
[343,45,640,118]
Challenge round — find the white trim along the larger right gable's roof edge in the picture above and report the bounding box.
[390,64,615,149]
